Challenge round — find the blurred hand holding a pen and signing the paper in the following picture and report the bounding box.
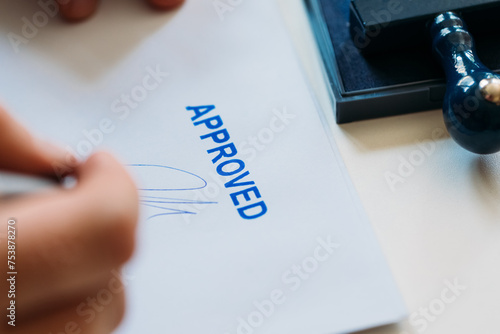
[0,109,138,334]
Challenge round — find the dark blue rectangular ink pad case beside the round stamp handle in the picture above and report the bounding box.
[305,0,500,123]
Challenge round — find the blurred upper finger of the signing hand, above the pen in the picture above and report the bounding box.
[0,108,76,176]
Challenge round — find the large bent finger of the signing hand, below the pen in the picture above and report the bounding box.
[0,153,138,314]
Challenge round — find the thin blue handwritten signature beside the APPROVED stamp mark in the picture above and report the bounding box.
[128,164,217,219]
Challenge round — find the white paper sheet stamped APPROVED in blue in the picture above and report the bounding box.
[0,0,405,334]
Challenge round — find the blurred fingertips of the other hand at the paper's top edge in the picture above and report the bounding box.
[57,0,184,21]
